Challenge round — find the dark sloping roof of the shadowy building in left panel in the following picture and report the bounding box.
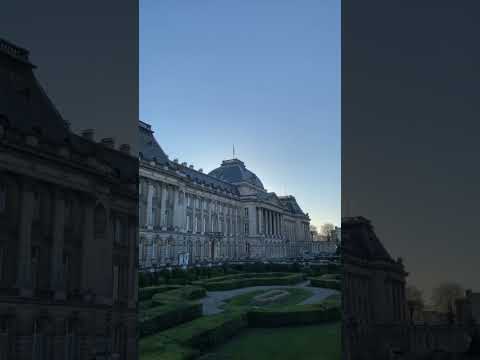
[0,38,138,183]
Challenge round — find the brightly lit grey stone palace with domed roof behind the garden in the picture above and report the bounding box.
[139,122,311,269]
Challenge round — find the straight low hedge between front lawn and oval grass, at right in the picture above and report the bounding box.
[247,304,341,327]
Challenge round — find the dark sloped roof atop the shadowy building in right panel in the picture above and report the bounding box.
[341,216,394,262]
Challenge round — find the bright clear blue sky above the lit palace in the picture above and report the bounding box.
[140,0,341,226]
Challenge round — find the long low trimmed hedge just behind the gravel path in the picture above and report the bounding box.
[194,273,304,291]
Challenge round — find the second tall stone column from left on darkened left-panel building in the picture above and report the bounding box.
[50,189,66,300]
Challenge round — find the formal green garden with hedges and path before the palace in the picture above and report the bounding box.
[139,263,342,360]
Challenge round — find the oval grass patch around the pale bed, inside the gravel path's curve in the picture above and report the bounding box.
[223,288,312,311]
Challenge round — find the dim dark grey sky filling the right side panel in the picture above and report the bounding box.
[342,0,480,300]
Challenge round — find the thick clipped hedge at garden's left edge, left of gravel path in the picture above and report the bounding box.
[139,286,206,336]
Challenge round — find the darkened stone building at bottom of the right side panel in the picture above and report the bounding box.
[341,217,468,360]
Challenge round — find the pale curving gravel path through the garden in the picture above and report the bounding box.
[200,281,338,315]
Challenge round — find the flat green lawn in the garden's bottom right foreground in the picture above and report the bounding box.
[208,322,341,360]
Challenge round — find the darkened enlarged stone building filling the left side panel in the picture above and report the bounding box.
[0,40,138,360]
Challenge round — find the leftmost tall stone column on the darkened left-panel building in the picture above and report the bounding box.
[17,179,35,297]
